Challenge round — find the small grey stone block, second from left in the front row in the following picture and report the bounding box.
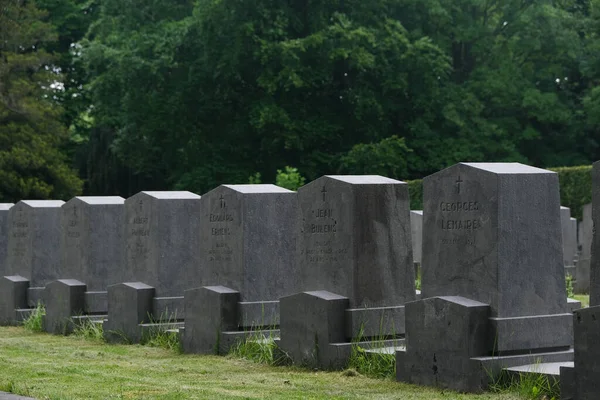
[44,279,87,335]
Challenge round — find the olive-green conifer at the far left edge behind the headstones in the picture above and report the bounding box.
[0,0,81,201]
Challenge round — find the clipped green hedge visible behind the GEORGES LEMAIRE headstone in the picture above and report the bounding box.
[407,165,592,220]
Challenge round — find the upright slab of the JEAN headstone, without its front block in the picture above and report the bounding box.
[298,175,415,308]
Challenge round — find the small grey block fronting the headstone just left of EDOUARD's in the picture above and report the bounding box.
[104,282,154,343]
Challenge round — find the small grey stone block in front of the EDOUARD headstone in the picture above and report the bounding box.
[183,286,240,354]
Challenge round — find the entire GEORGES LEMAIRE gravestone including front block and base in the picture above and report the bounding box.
[396,163,573,391]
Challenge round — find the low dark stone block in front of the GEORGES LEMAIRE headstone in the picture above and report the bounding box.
[396,296,493,392]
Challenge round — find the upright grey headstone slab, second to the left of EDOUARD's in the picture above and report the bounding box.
[61,196,125,291]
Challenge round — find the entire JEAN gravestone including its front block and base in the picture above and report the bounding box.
[280,175,416,368]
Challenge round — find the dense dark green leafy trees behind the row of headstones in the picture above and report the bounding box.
[0,0,600,198]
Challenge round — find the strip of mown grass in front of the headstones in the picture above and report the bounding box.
[0,327,521,400]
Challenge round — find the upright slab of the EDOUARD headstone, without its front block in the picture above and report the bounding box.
[199,185,299,302]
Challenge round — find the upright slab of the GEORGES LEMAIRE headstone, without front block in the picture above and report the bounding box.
[421,163,570,320]
